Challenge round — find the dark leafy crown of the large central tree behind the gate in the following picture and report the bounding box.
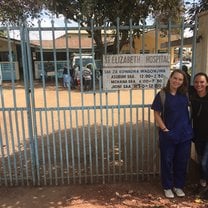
[44,0,184,56]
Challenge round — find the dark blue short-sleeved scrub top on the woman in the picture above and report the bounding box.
[151,92,193,143]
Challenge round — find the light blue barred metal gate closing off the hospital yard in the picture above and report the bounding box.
[0,17,196,186]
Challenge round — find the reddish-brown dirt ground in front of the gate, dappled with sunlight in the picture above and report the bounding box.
[0,81,208,208]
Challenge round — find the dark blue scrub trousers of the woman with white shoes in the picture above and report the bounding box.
[160,139,191,189]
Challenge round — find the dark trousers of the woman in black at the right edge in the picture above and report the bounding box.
[195,141,208,180]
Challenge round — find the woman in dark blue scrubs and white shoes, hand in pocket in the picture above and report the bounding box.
[151,70,193,198]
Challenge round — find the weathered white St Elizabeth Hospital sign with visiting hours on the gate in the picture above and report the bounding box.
[103,54,170,90]
